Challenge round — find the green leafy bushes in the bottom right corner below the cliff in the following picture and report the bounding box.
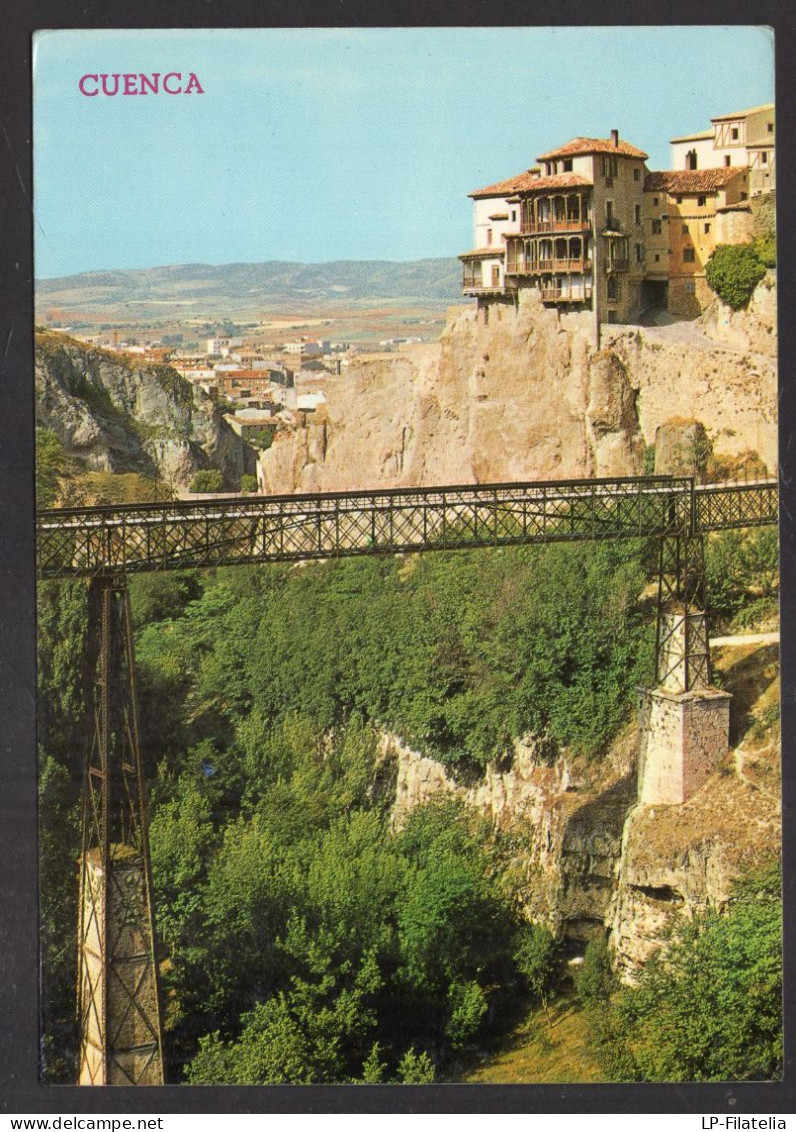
[591,864,782,1081]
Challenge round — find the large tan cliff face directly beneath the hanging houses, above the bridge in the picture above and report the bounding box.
[263,275,777,494]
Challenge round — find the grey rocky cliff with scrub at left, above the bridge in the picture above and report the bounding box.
[36,335,246,487]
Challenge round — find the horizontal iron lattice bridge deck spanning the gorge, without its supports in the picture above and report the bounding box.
[36,477,778,577]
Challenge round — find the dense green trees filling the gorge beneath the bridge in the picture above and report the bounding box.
[40,529,773,1083]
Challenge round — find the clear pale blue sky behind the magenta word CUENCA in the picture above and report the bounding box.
[34,26,773,278]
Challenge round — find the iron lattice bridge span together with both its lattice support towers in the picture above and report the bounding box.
[37,477,777,1084]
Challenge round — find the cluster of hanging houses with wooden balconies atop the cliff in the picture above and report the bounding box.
[459,103,774,323]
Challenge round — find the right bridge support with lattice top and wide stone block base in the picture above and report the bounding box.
[639,537,731,805]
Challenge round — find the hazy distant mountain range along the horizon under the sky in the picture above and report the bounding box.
[36,258,461,317]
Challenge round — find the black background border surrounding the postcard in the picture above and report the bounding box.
[0,0,796,1115]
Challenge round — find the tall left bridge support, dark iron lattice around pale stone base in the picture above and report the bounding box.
[77,575,163,1084]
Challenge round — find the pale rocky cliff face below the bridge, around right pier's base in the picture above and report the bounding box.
[384,645,780,980]
